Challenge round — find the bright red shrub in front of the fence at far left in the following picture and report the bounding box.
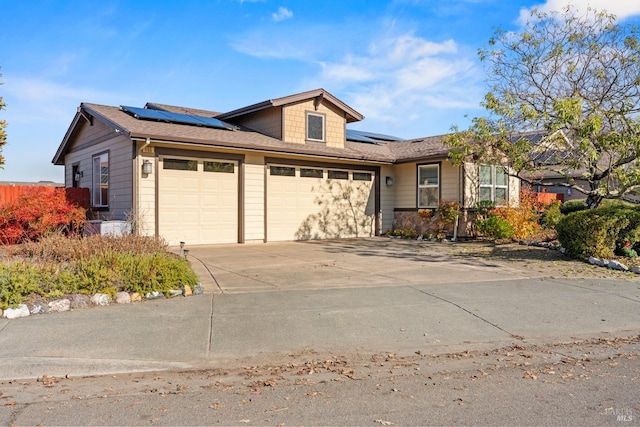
[0,187,86,245]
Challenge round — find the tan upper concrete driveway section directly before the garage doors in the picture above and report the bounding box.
[189,237,552,293]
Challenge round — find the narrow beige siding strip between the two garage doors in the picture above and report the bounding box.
[244,154,265,242]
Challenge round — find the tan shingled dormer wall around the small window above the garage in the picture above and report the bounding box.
[283,99,347,148]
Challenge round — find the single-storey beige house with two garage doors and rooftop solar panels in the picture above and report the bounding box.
[53,89,519,245]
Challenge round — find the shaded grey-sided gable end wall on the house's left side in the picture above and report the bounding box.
[64,120,133,220]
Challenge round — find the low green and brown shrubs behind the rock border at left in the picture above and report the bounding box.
[0,235,198,309]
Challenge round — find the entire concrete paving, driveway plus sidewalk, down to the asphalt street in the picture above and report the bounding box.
[0,243,640,380]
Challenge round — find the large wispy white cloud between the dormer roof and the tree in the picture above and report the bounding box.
[307,34,483,136]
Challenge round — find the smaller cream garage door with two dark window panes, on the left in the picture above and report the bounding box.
[158,157,238,245]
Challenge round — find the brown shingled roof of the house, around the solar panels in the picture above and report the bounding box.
[53,89,449,165]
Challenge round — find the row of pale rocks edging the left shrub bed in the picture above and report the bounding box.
[0,283,204,319]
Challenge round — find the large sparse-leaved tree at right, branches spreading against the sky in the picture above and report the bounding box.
[447,6,640,208]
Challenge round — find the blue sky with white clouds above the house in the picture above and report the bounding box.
[0,0,640,182]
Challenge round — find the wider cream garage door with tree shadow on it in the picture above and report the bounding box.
[267,165,375,241]
